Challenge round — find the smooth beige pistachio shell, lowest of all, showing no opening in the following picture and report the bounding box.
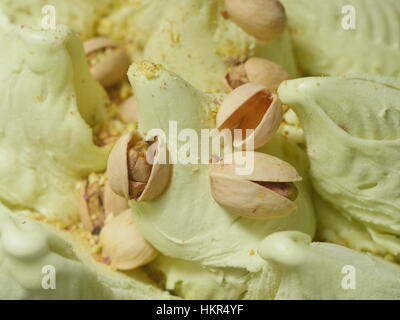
[99,210,158,270]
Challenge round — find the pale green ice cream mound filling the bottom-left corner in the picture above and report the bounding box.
[0,203,173,299]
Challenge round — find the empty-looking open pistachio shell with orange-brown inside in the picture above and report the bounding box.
[216,82,283,150]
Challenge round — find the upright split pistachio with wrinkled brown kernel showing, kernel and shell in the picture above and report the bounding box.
[107,133,171,201]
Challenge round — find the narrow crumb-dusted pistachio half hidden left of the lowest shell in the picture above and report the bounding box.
[79,180,105,234]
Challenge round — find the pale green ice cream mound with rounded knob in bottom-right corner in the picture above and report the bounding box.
[259,231,400,300]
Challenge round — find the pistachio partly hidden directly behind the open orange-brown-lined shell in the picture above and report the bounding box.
[225,57,290,93]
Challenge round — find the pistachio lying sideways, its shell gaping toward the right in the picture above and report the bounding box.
[210,151,301,219]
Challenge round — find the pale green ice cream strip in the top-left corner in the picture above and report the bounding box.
[0,0,120,39]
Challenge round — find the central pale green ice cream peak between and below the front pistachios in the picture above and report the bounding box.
[128,63,315,296]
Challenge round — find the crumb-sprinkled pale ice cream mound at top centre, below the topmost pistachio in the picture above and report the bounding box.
[99,0,298,92]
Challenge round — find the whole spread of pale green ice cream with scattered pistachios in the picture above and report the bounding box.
[0,0,400,299]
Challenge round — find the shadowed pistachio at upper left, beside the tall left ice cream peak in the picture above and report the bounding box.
[84,37,131,87]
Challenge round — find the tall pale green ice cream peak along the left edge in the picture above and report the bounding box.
[0,25,108,222]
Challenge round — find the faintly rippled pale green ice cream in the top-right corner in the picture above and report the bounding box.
[281,0,400,77]
